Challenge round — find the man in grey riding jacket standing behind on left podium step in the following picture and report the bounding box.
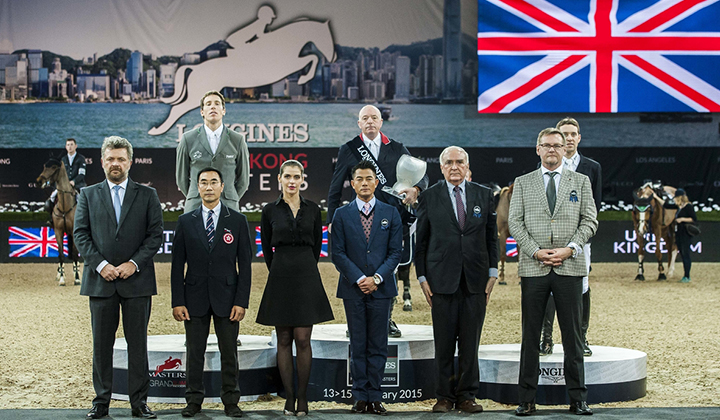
[175,90,250,213]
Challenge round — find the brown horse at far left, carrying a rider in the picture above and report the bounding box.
[37,159,80,286]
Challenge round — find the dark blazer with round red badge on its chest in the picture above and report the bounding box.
[170,204,252,317]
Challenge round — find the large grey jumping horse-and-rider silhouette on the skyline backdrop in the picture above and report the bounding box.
[148,6,335,136]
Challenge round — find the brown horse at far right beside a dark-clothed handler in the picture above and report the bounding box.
[632,184,677,280]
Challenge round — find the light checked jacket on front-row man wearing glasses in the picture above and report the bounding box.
[508,169,598,277]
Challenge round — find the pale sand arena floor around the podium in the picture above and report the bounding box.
[0,263,720,411]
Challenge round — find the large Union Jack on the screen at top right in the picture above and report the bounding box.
[478,0,720,113]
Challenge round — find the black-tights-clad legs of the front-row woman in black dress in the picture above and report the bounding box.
[275,325,312,412]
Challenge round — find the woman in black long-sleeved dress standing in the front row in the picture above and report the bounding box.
[256,160,334,416]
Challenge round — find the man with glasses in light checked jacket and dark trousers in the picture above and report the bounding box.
[508,128,598,416]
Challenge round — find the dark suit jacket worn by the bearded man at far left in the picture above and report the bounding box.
[73,179,163,298]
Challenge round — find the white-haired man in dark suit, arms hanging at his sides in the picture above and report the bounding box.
[415,146,498,413]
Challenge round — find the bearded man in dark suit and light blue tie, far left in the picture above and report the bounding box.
[74,136,163,419]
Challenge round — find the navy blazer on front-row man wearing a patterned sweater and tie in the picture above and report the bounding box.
[331,200,402,299]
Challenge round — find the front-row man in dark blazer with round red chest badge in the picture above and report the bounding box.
[171,167,252,417]
